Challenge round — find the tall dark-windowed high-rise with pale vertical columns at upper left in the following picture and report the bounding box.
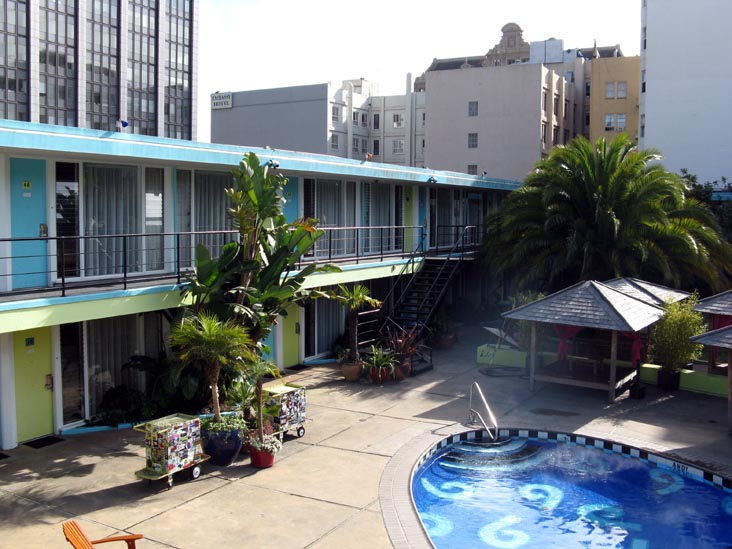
[0,0,198,139]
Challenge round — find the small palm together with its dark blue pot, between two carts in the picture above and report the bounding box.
[170,311,253,466]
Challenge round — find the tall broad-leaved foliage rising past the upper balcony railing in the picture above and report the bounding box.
[184,152,340,344]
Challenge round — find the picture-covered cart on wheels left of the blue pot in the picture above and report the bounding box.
[133,414,210,487]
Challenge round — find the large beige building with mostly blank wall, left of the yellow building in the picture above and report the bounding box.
[424,63,574,181]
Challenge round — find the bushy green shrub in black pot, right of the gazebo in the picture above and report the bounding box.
[649,294,707,390]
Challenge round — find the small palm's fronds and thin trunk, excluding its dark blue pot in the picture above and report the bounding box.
[170,311,254,422]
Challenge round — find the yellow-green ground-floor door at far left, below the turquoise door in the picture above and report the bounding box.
[13,328,53,442]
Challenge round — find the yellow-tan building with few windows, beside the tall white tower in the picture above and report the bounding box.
[590,56,640,143]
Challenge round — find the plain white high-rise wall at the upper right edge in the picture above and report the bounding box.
[639,0,732,182]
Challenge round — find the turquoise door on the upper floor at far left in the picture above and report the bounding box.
[10,158,49,289]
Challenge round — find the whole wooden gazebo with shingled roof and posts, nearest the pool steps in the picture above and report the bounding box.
[503,280,664,402]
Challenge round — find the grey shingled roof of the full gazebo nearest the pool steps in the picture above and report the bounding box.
[503,280,664,332]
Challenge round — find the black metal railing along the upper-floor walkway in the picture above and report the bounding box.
[0,225,483,302]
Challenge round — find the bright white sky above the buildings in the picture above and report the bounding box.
[198,0,641,141]
